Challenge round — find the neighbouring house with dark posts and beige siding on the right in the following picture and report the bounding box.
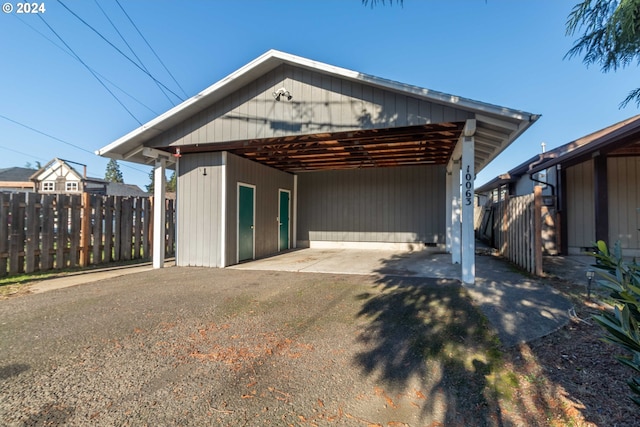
[475,115,640,256]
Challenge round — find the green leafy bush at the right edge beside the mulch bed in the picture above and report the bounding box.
[593,241,640,406]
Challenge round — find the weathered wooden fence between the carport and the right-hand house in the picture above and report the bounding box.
[476,186,543,276]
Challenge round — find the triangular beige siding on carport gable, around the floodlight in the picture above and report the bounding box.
[149,65,473,146]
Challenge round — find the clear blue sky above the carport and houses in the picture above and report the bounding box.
[0,0,640,186]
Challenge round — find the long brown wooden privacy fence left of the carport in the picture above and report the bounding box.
[0,193,175,276]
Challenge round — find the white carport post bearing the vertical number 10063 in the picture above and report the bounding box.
[462,135,476,285]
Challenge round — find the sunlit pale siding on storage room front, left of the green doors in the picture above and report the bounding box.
[176,153,223,267]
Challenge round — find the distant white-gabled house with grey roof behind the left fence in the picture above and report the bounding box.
[30,158,149,197]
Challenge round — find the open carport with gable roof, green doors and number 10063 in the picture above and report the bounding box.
[97,50,539,283]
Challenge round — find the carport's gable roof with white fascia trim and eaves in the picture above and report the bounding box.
[96,50,540,172]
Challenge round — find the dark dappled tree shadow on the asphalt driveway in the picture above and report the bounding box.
[355,276,502,426]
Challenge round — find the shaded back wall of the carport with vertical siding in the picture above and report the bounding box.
[297,166,445,243]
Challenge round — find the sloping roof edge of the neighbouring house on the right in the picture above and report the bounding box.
[475,114,640,193]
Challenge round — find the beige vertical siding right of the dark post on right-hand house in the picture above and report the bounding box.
[607,157,640,250]
